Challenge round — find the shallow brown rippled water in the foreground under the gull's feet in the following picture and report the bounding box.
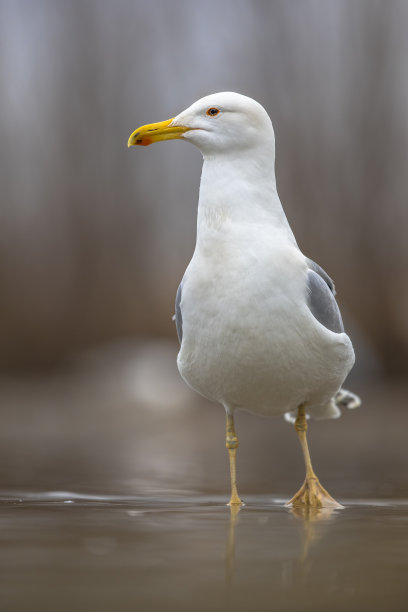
[0,492,408,611]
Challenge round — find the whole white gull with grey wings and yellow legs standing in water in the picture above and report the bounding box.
[128,92,361,508]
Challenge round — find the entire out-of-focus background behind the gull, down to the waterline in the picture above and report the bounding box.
[0,0,408,498]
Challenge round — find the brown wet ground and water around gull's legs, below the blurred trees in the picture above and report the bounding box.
[0,342,408,612]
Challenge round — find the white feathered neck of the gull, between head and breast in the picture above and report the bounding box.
[197,143,295,244]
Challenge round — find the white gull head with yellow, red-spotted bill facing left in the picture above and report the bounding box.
[128,92,274,157]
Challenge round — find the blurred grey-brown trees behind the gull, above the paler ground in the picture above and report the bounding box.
[0,0,408,374]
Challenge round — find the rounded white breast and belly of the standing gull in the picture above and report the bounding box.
[178,224,352,414]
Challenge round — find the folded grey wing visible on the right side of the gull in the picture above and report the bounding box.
[307,268,344,334]
